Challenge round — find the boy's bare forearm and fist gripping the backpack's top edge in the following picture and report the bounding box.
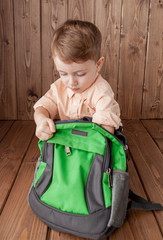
[34,107,56,141]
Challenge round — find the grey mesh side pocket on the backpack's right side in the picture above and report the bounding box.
[107,169,129,227]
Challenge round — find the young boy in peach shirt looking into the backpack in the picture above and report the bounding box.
[34,20,122,140]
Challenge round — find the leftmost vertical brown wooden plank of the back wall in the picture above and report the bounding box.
[0,0,17,120]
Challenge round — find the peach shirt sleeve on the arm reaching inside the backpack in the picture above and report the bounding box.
[92,85,122,129]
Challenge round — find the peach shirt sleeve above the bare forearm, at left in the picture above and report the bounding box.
[33,83,58,119]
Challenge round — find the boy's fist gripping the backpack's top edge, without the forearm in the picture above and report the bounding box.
[36,117,56,141]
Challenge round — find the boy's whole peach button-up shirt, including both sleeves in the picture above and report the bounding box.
[34,75,122,129]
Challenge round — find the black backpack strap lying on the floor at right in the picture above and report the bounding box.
[127,190,163,211]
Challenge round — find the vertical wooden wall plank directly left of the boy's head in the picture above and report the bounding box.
[41,0,67,94]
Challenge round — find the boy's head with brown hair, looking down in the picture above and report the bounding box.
[52,20,104,93]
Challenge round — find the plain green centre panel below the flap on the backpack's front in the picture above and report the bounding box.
[40,144,95,214]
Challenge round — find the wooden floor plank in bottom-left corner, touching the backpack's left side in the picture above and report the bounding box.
[0,162,47,240]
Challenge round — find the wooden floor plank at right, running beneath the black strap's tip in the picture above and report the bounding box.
[124,120,163,232]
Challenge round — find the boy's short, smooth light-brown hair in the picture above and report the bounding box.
[51,20,102,62]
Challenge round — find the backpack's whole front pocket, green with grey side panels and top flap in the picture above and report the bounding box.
[36,128,109,215]
